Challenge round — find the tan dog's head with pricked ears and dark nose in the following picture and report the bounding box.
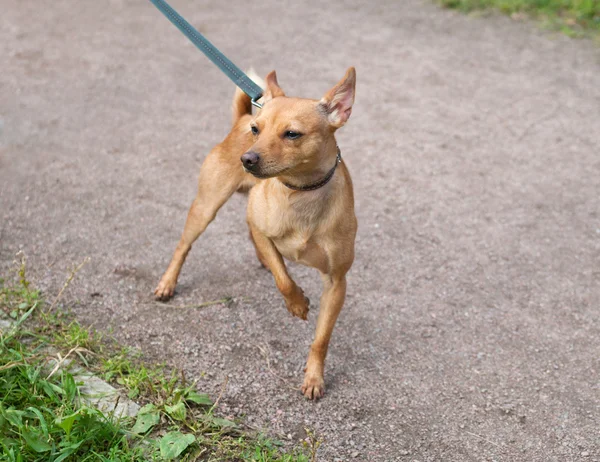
[241,67,356,178]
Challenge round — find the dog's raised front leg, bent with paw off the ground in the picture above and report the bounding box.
[248,226,309,320]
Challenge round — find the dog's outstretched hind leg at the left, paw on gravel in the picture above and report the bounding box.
[154,146,251,300]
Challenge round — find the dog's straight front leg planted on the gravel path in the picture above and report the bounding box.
[302,274,346,399]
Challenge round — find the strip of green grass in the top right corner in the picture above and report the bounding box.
[437,0,600,38]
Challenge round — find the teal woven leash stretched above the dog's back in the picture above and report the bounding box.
[150,0,262,108]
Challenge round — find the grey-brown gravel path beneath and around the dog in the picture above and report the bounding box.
[0,0,600,462]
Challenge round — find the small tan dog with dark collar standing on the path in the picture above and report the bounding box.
[154,68,357,399]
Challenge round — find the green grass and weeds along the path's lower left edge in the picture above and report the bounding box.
[0,260,320,462]
